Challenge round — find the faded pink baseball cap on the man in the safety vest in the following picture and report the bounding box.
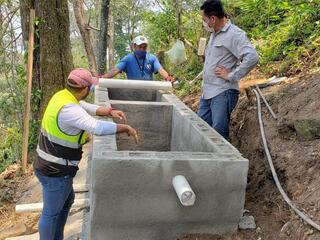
[68,68,99,87]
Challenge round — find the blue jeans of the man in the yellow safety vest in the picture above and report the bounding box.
[35,171,74,240]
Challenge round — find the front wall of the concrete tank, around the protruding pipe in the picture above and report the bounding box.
[91,152,248,240]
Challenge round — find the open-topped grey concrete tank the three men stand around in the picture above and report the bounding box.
[90,89,248,240]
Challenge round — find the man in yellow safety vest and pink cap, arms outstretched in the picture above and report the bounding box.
[33,68,138,240]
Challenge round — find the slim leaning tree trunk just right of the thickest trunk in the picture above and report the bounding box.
[73,0,97,74]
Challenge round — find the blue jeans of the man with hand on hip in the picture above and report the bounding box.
[198,89,239,140]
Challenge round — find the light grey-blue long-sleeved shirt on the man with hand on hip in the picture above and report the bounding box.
[202,21,259,99]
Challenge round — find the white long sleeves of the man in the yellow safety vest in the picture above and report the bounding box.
[58,101,117,135]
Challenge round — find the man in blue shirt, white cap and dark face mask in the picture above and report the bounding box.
[100,36,174,82]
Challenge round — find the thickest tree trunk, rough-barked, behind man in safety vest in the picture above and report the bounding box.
[34,0,73,115]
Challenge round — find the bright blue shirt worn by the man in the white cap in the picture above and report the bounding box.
[117,53,161,80]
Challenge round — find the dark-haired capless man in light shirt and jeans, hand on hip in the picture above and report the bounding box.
[198,0,259,139]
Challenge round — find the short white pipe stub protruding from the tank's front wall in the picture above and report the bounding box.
[172,175,196,207]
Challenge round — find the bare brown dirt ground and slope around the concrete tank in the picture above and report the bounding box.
[0,70,320,240]
